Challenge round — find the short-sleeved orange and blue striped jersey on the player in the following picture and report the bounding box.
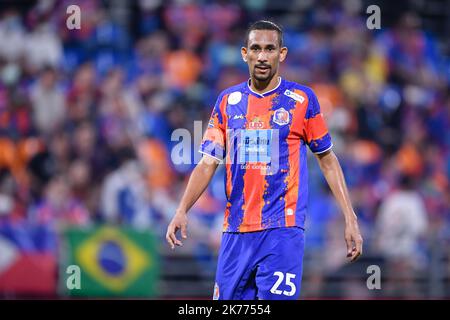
[199,78,332,232]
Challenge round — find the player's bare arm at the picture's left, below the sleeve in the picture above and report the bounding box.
[166,155,219,249]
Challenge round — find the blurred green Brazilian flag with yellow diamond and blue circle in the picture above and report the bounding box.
[59,226,159,297]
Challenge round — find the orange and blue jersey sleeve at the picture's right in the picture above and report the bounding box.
[303,92,333,154]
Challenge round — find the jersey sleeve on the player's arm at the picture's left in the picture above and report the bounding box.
[199,94,226,161]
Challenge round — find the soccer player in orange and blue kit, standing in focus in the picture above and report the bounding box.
[166,21,362,300]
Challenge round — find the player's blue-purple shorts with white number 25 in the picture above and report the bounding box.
[213,227,304,300]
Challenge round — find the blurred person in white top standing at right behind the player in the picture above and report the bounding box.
[375,176,429,297]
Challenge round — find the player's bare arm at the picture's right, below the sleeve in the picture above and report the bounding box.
[315,150,363,261]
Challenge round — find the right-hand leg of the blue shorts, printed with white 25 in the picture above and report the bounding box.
[256,227,304,300]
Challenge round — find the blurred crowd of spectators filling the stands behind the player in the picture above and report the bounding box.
[0,0,450,298]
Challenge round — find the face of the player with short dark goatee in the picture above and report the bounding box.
[241,30,287,81]
